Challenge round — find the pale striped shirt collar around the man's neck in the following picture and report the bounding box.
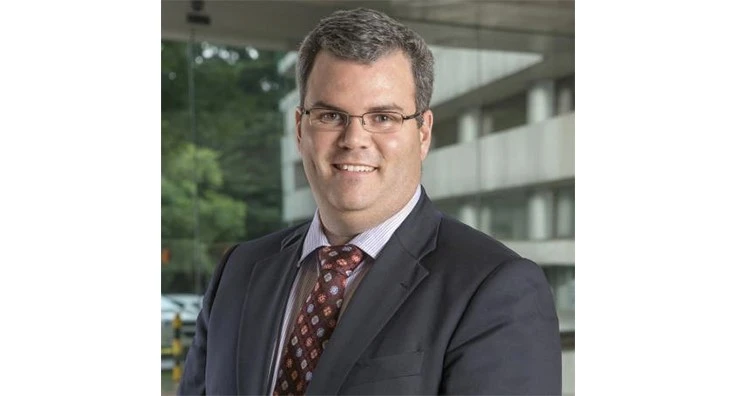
[297,185,422,266]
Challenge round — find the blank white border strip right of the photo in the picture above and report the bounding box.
[575,1,736,395]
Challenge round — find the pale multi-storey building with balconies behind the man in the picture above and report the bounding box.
[279,47,575,394]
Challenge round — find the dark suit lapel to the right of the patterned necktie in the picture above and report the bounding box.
[307,192,440,395]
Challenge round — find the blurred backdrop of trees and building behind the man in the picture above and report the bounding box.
[161,0,575,395]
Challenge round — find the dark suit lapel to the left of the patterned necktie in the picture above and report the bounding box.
[235,227,306,394]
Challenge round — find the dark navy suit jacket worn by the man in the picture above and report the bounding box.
[179,191,561,395]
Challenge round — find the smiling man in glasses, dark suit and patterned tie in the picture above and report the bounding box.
[179,9,561,395]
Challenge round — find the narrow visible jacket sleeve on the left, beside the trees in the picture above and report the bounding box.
[177,245,238,395]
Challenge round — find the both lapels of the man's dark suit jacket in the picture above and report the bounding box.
[264,187,441,395]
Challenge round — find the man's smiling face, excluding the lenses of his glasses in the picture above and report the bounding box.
[296,51,432,227]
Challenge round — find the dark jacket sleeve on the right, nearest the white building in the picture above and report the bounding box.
[440,259,562,395]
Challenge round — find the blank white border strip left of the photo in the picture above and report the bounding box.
[0,1,161,394]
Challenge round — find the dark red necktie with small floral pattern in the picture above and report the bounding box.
[273,245,363,396]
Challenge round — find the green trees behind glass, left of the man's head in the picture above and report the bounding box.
[161,41,293,287]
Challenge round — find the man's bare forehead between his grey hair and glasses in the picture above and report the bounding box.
[305,51,415,111]
